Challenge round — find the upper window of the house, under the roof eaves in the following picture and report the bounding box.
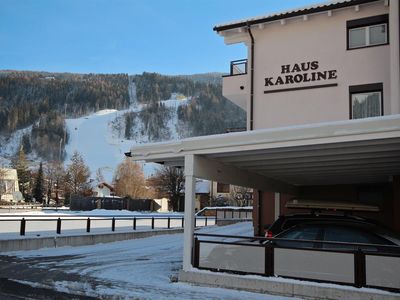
[347,15,389,49]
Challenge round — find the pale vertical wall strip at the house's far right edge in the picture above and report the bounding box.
[389,0,400,114]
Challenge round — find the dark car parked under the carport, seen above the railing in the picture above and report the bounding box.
[273,218,400,254]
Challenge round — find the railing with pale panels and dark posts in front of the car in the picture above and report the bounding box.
[192,233,400,292]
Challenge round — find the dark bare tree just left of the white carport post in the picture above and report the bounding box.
[148,166,185,211]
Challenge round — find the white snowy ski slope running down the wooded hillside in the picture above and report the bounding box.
[65,94,189,182]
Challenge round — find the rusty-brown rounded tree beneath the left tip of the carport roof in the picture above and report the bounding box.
[113,158,148,199]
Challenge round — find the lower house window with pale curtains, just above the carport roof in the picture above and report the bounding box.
[349,83,383,119]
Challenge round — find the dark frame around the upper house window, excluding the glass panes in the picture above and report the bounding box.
[346,14,389,50]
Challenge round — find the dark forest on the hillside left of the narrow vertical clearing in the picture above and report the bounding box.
[0,71,129,133]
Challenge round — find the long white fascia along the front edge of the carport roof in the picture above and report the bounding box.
[131,114,400,161]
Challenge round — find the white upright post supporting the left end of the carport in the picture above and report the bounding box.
[183,154,196,271]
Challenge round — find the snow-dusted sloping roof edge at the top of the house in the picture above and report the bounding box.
[214,0,380,31]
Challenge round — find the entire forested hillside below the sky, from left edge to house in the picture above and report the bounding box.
[0,71,245,161]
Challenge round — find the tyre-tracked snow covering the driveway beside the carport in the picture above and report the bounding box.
[6,222,296,300]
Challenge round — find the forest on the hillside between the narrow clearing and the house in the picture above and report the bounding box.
[131,73,246,136]
